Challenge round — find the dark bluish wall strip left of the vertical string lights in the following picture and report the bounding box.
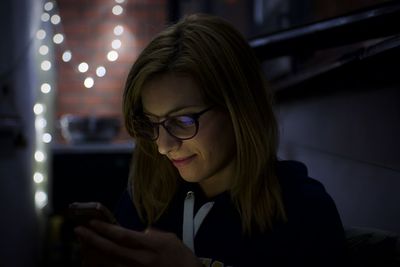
[0,0,40,267]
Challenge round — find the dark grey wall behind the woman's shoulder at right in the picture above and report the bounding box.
[277,45,400,233]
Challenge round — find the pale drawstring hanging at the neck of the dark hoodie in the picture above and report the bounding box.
[182,191,214,253]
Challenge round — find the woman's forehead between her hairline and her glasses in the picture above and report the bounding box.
[141,74,204,116]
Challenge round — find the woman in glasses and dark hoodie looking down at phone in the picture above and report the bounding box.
[76,15,344,266]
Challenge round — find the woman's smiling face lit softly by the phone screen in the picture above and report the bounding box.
[142,74,236,196]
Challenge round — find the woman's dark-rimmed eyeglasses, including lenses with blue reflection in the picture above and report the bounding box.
[134,107,212,141]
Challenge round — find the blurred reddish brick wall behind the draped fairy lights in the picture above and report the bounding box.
[55,0,167,142]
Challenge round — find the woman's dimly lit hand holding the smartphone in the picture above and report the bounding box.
[75,220,202,267]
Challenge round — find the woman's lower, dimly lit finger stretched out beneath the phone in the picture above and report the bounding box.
[75,226,154,266]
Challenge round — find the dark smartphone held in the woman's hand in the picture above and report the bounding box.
[68,202,118,225]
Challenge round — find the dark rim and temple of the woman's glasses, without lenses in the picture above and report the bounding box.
[133,106,214,141]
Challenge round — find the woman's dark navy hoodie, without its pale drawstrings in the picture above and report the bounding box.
[115,161,345,267]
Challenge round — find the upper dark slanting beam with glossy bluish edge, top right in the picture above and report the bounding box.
[249,1,400,61]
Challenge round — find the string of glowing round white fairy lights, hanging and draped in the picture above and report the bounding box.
[33,0,130,210]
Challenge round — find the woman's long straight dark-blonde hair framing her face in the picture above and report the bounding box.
[123,14,286,233]
